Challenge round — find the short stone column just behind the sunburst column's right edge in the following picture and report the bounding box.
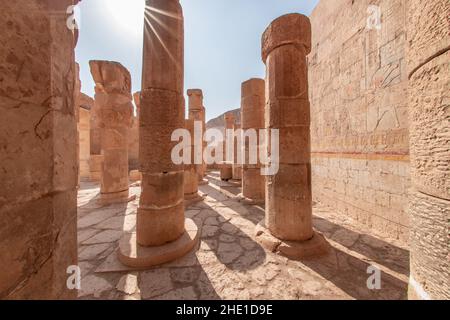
[184,119,201,204]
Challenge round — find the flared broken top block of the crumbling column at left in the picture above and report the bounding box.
[89,60,131,96]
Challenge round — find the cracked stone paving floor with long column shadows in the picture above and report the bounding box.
[78,172,409,300]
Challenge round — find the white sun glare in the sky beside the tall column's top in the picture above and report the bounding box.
[106,0,145,34]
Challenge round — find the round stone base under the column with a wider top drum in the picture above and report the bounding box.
[255,221,330,260]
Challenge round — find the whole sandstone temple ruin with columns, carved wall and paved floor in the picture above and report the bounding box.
[0,0,450,300]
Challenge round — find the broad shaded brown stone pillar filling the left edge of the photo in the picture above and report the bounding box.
[0,0,78,299]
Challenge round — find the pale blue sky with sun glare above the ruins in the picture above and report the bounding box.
[76,0,319,120]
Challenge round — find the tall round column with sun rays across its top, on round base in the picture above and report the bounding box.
[119,0,198,268]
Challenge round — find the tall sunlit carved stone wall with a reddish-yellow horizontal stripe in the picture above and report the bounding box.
[309,0,410,241]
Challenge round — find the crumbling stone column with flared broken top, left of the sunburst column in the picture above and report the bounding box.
[89,61,135,203]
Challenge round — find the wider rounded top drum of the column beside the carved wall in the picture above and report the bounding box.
[262,13,311,63]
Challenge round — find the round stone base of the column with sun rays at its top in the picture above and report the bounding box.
[118,219,200,269]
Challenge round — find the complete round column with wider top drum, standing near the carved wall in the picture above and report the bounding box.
[256,14,326,258]
